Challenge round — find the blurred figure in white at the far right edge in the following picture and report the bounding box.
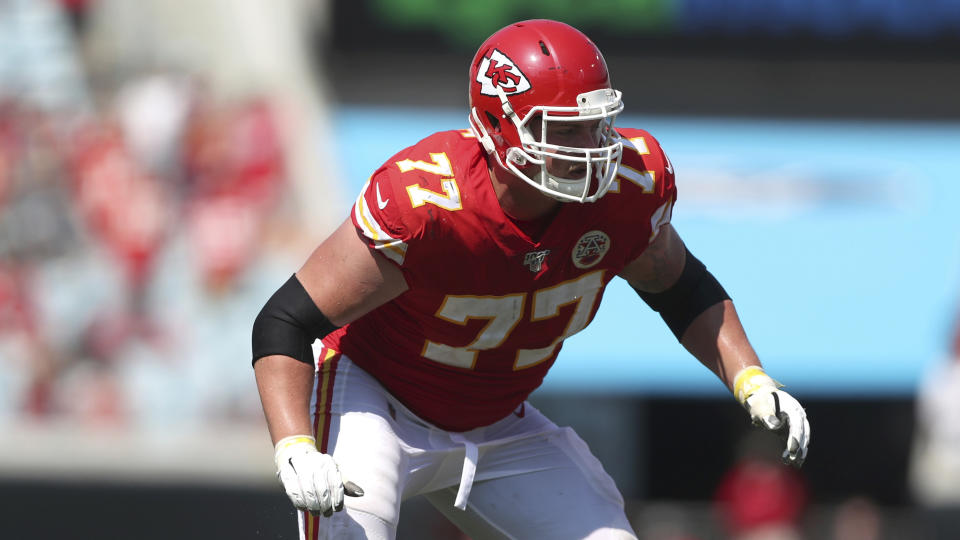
[910,306,960,538]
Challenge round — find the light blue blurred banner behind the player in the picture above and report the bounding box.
[335,107,960,397]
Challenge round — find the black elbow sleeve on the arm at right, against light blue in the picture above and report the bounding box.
[634,248,730,341]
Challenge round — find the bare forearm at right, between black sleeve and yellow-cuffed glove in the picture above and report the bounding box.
[680,300,760,391]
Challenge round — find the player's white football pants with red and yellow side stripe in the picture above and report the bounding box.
[299,347,636,540]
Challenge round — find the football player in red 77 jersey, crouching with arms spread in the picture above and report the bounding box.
[253,20,810,540]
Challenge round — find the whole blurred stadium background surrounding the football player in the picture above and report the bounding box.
[0,0,960,540]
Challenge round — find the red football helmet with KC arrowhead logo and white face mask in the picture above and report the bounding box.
[470,19,623,202]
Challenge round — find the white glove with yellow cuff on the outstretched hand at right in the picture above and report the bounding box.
[733,366,810,467]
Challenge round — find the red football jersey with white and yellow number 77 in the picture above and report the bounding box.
[323,129,676,431]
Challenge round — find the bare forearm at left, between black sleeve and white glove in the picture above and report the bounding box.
[253,355,314,444]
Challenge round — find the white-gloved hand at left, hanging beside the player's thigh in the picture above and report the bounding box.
[273,435,363,517]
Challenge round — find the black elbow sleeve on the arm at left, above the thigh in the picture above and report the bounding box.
[253,274,338,364]
